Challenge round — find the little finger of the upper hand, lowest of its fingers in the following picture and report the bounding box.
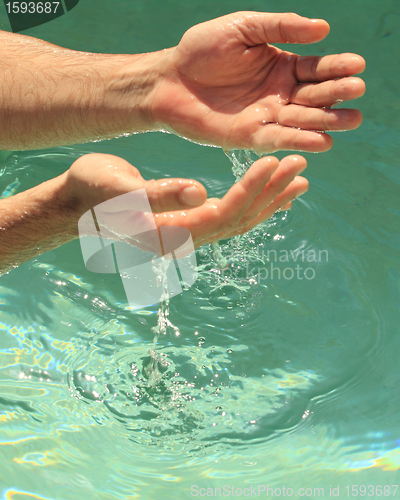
[251,123,332,153]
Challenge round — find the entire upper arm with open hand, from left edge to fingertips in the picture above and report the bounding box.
[0,12,365,153]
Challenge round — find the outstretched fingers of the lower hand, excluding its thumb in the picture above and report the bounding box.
[154,155,308,248]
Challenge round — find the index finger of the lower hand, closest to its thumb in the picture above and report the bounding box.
[219,156,279,220]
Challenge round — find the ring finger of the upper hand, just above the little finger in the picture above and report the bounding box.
[278,104,362,131]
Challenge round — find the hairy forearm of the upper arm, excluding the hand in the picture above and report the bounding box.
[0,32,168,150]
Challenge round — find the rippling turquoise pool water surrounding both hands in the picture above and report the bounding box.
[0,0,400,500]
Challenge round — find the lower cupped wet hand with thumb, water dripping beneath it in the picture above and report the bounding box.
[65,154,308,250]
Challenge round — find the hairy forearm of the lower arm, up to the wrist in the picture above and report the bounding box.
[0,174,78,275]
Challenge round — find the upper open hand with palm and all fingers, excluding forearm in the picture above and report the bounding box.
[152,12,365,153]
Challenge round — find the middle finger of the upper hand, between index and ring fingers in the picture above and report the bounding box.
[290,77,365,108]
